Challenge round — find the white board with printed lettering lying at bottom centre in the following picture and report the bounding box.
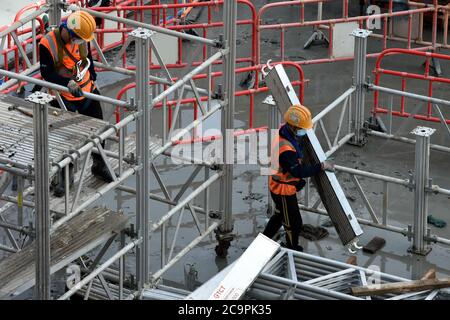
[208,233,280,300]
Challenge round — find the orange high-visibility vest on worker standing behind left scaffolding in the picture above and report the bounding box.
[40,29,95,101]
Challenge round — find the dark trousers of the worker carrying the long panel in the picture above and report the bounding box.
[263,192,303,250]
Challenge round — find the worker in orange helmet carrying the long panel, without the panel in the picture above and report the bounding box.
[263,105,334,251]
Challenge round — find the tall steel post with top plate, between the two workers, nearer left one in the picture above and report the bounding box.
[130,28,154,289]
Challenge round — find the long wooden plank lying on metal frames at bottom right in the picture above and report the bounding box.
[351,278,450,296]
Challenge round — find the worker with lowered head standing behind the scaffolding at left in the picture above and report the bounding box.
[39,11,113,197]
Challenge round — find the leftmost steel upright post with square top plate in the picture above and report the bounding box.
[26,92,53,300]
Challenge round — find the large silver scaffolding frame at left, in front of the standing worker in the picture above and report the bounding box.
[0,1,236,299]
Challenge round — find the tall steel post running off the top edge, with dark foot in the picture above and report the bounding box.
[216,0,237,257]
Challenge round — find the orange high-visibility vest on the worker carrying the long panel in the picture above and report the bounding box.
[269,135,301,196]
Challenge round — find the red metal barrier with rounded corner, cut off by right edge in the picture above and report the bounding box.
[372,49,450,123]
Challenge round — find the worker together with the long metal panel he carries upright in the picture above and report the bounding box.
[262,61,363,252]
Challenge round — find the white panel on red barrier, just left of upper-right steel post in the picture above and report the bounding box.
[331,22,359,58]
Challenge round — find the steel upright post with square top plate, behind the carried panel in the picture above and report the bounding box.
[349,29,372,146]
